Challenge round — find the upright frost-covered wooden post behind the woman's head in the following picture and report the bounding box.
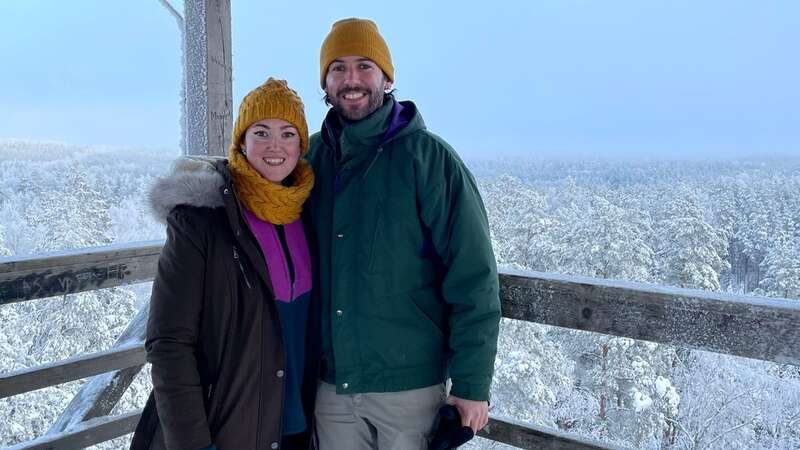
[183,0,233,156]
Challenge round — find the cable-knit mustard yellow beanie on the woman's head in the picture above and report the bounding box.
[228,77,308,155]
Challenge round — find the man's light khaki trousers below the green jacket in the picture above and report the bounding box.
[314,382,446,450]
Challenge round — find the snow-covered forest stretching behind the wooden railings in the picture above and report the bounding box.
[0,140,800,450]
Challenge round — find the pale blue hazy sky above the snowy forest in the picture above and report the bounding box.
[0,0,800,158]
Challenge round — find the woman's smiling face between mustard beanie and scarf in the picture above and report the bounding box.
[241,119,300,184]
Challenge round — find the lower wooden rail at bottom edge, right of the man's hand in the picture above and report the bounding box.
[478,417,624,450]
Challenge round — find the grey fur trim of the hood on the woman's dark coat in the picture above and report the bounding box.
[148,156,225,223]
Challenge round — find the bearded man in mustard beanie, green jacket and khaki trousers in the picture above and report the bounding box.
[306,19,500,450]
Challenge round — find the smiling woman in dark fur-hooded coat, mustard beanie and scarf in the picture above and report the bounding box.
[131,78,319,450]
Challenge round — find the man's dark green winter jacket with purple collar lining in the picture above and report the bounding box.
[306,97,500,400]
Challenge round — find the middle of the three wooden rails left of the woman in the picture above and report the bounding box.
[0,342,145,398]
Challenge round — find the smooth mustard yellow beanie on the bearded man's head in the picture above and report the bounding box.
[319,18,394,89]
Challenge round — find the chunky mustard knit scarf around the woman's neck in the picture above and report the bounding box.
[228,149,314,225]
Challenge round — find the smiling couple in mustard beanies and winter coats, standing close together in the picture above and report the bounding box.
[131,19,500,450]
